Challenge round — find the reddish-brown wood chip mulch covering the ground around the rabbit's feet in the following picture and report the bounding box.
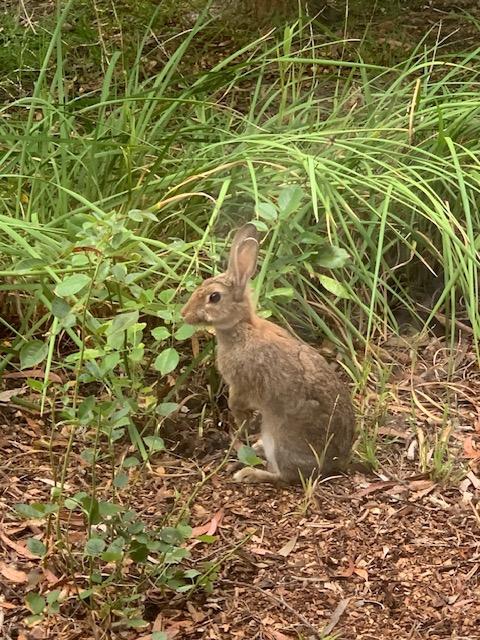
[0,339,480,640]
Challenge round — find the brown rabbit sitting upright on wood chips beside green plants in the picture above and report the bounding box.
[181,223,355,484]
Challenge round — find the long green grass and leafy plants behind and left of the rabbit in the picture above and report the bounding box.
[0,2,480,632]
